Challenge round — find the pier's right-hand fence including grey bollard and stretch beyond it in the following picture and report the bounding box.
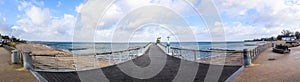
[159,43,272,66]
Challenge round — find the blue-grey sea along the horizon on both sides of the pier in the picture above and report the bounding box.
[31,41,265,54]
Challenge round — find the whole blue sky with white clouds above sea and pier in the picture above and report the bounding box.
[0,0,300,42]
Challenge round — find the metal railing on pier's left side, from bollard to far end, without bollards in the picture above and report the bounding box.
[27,42,152,71]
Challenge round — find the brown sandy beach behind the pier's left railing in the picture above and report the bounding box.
[16,43,110,70]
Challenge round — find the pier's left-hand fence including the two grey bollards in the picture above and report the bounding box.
[12,43,152,71]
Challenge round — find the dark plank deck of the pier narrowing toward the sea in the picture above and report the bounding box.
[37,45,242,82]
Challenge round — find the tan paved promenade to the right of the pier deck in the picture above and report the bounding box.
[235,47,300,82]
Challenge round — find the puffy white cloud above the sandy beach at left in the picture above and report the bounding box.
[11,2,76,41]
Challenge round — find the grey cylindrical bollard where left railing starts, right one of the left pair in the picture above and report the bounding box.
[23,51,32,70]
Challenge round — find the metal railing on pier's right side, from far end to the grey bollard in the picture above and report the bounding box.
[159,44,243,65]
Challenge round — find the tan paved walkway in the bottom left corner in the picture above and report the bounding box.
[0,47,37,82]
